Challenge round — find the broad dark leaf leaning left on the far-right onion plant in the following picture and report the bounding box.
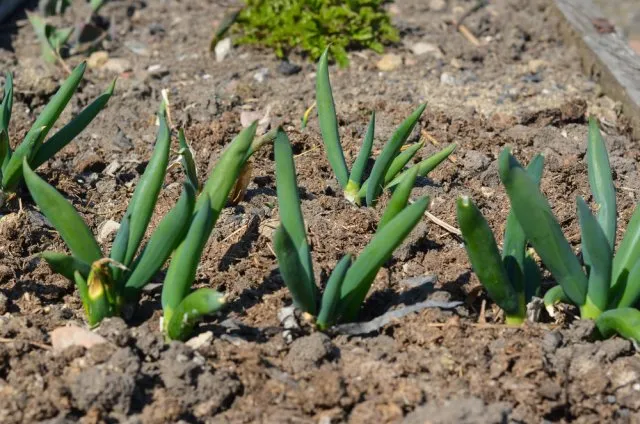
[499,149,588,306]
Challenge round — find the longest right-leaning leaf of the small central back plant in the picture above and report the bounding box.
[366,104,427,206]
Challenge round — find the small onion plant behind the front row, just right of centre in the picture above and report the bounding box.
[316,49,456,206]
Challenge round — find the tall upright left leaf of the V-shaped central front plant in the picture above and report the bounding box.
[274,127,317,315]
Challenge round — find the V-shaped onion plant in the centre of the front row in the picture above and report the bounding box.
[273,128,429,329]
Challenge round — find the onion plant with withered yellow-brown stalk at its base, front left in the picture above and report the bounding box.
[22,106,195,326]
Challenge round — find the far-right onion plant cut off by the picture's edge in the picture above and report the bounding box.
[499,119,640,341]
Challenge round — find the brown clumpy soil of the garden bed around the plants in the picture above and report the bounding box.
[0,0,640,424]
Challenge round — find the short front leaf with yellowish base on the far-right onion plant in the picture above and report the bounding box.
[577,196,613,318]
